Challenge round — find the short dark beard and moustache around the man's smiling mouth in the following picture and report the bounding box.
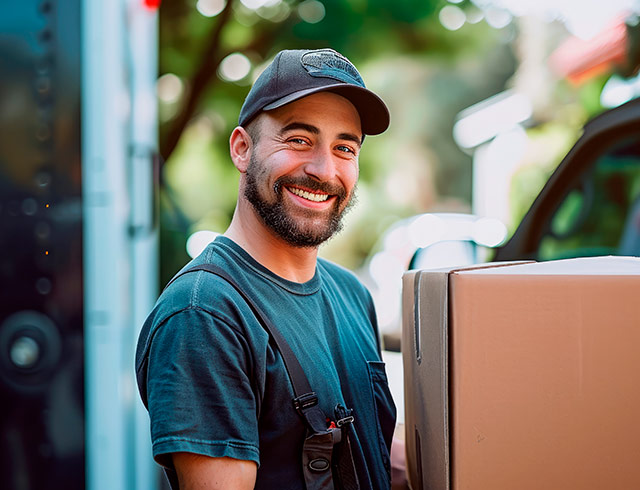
[244,154,356,248]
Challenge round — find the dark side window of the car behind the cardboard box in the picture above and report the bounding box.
[539,137,640,260]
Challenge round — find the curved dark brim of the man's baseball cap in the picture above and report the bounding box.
[262,83,390,135]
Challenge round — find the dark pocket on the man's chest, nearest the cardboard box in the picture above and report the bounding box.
[367,361,396,477]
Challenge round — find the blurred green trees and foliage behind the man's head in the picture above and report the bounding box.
[159,0,603,277]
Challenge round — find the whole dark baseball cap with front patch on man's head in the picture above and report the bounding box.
[238,49,389,135]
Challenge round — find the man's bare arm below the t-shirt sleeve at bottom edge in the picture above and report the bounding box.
[173,453,258,490]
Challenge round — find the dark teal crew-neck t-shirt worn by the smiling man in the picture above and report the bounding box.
[136,237,396,489]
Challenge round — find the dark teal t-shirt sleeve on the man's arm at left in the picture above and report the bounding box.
[147,309,260,468]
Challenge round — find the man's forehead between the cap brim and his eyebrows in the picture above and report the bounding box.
[263,92,362,136]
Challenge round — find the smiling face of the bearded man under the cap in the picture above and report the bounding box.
[244,93,362,247]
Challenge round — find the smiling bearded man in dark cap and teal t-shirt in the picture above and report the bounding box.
[136,49,395,490]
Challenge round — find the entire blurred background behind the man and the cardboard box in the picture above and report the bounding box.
[0,0,640,490]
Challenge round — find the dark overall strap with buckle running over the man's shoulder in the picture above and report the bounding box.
[165,264,327,432]
